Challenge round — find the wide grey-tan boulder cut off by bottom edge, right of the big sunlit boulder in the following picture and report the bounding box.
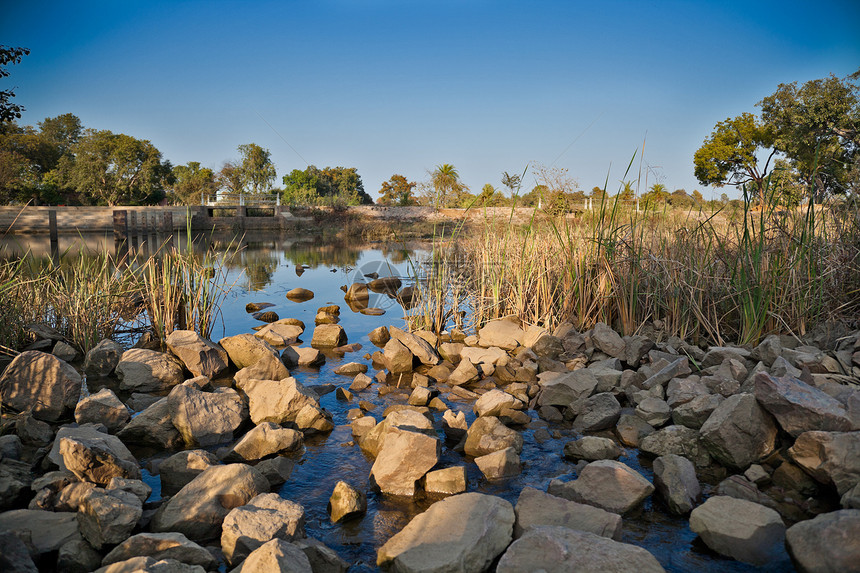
[496,526,664,573]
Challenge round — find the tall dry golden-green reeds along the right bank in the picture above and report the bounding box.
[413,183,860,344]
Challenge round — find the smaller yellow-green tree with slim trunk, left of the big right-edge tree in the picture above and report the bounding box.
[693,113,776,203]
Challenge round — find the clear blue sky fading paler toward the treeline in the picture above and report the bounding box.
[0,0,860,199]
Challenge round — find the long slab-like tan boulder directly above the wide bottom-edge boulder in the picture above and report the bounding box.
[514,487,621,541]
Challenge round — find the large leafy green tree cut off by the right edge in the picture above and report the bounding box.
[758,72,860,196]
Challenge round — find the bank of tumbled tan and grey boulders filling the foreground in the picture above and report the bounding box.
[0,285,860,572]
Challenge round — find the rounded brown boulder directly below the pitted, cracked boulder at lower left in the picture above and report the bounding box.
[77,488,143,549]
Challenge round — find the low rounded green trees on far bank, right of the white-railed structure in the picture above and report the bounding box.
[283,165,373,207]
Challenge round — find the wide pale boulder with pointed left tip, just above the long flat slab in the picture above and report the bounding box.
[555,460,654,514]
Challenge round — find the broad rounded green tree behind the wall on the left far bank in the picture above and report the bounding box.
[59,129,172,205]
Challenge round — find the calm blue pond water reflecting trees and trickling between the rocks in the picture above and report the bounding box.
[0,230,793,572]
